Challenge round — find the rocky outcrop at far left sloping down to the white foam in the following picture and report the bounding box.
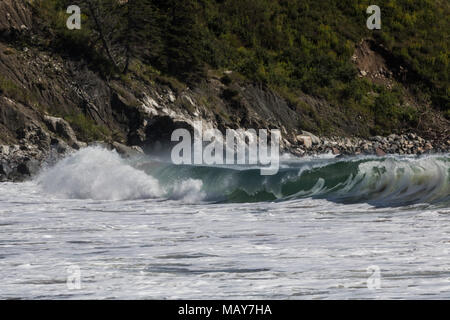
[0,97,81,181]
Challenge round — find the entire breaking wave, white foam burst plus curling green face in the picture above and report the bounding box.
[36,147,450,206]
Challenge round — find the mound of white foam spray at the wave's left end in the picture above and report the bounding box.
[36,146,164,200]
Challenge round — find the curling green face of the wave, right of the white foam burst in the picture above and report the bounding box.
[141,155,450,206]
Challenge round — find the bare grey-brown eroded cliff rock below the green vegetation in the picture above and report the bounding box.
[0,0,447,180]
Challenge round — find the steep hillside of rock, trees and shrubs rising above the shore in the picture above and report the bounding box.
[0,0,450,180]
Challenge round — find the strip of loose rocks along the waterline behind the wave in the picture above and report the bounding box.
[0,131,450,182]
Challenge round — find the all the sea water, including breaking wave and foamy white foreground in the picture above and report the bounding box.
[0,147,450,299]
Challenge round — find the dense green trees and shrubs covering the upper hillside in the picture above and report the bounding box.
[38,0,450,133]
